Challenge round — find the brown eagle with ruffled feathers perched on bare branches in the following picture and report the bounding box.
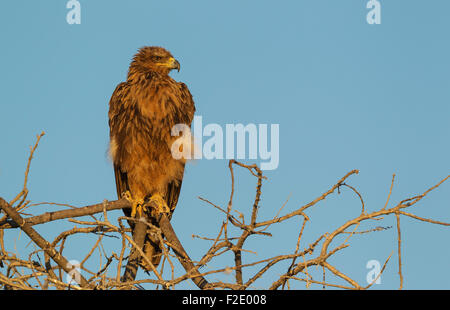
[108,47,195,270]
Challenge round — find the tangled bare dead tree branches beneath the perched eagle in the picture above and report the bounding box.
[0,133,450,290]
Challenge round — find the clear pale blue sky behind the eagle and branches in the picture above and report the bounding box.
[0,0,450,289]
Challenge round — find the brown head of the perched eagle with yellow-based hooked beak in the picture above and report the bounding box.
[130,46,180,75]
